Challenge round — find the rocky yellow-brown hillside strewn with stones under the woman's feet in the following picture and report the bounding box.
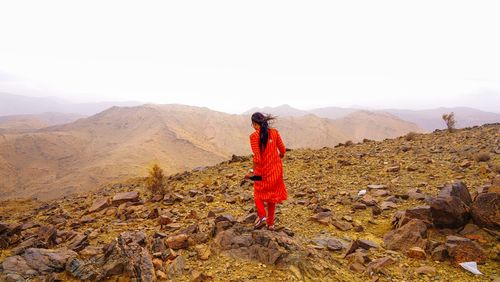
[0,124,500,281]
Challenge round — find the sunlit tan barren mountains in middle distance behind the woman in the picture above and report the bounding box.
[0,105,421,199]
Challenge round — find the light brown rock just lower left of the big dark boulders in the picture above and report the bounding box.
[384,219,427,251]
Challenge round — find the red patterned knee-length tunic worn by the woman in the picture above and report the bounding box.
[250,128,287,203]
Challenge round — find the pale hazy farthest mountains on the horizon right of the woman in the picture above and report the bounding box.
[245,105,500,131]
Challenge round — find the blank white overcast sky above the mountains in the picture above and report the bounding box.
[0,0,500,113]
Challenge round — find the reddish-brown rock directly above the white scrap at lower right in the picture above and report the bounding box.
[446,236,486,265]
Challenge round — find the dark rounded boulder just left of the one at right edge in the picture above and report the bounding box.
[431,196,470,228]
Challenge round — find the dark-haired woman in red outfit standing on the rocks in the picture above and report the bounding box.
[245,112,287,230]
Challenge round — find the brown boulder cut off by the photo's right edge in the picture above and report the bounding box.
[471,193,500,229]
